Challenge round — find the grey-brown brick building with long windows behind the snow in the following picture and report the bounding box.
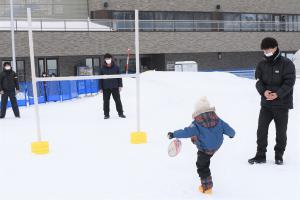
[0,0,300,79]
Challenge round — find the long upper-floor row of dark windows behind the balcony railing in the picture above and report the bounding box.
[109,11,300,32]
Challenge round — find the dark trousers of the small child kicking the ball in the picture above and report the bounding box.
[196,151,213,179]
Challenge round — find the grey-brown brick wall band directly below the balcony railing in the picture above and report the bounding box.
[0,32,300,57]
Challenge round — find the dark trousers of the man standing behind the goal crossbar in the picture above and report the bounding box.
[103,88,123,116]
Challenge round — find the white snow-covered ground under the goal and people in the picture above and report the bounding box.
[0,72,300,200]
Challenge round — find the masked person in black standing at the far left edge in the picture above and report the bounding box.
[0,62,20,118]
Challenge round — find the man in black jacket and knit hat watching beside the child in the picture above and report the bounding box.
[248,38,296,165]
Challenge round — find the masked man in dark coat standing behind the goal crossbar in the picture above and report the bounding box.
[100,54,126,119]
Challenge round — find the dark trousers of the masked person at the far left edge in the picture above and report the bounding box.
[1,91,20,118]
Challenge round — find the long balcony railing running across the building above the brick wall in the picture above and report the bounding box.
[0,19,300,32]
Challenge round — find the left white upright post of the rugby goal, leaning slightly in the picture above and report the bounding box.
[27,8,42,142]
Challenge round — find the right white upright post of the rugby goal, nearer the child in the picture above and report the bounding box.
[135,10,140,132]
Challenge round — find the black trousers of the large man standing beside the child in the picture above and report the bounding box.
[257,107,289,156]
